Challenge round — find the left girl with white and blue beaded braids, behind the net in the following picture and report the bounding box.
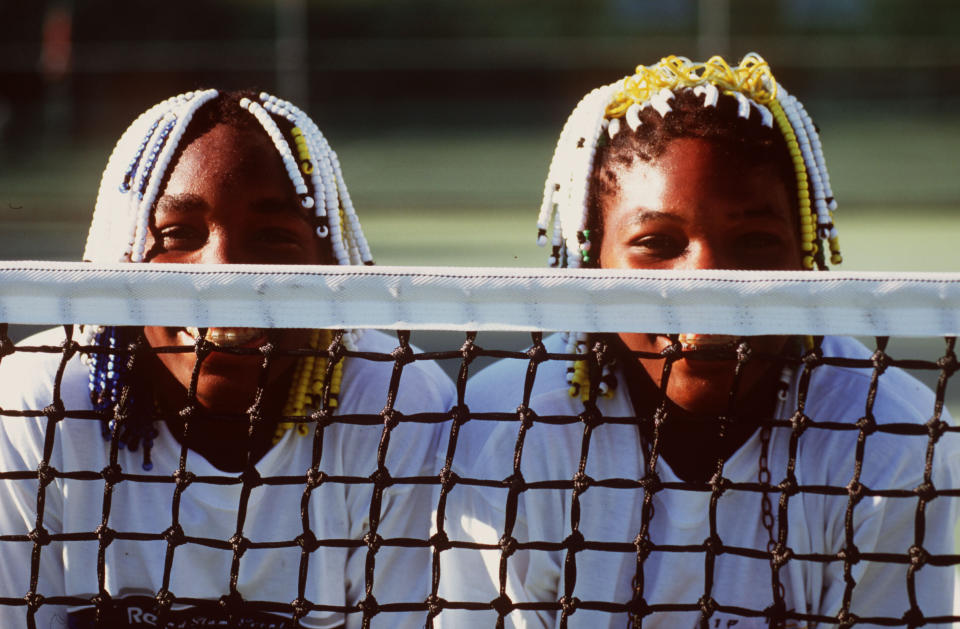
[0,90,453,629]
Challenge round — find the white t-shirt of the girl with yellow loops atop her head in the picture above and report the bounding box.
[438,337,960,629]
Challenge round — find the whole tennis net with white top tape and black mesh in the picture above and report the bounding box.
[0,262,960,627]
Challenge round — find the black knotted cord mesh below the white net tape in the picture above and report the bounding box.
[0,325,960,627]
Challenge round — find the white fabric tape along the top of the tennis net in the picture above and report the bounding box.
[0,261,960,336]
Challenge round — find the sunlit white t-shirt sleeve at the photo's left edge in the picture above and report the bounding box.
[0,344,65,628]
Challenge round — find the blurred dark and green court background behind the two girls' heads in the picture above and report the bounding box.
[0,0,960,410]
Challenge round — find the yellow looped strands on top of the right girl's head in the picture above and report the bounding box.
[606,53,777,119]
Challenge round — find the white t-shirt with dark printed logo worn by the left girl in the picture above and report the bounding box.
[0,330,454,629]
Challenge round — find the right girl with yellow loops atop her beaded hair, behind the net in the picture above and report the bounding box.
[439,54,960,629]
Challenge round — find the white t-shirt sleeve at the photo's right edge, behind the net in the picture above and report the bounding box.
[808,356,960,618]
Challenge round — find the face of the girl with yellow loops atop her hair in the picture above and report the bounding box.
[599,138,802,413]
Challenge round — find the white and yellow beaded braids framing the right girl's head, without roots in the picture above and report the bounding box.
[537,53,843,399]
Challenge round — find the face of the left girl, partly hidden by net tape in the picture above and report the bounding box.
[144,124,330,412]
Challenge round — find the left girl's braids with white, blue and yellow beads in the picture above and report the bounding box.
[79,89,373,470]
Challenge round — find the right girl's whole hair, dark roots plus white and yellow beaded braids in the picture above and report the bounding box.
[537,53,843,397]
